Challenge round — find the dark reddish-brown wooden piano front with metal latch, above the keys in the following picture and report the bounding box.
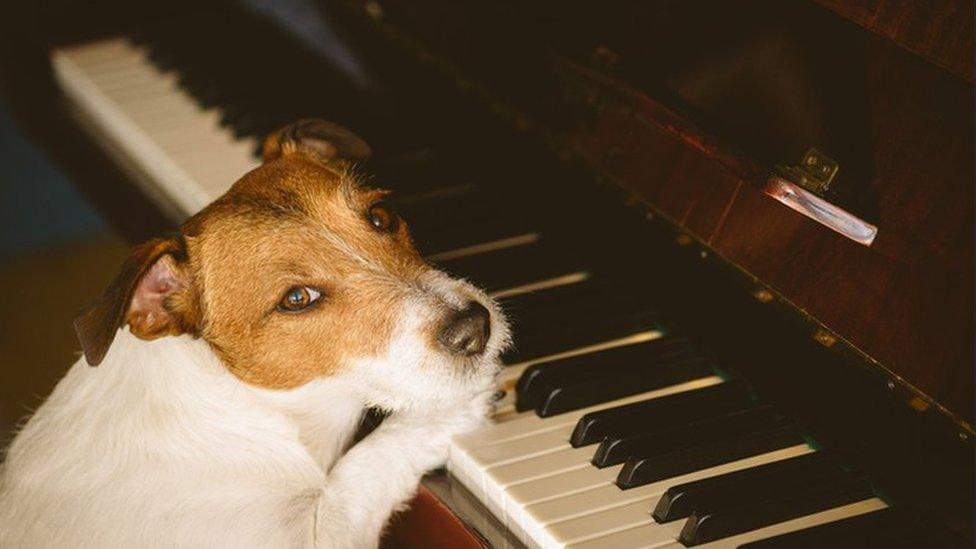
[332,0,973,421]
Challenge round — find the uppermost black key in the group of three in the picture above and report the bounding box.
[572,382,757,448]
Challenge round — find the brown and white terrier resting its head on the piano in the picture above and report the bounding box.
[0,120,509,548]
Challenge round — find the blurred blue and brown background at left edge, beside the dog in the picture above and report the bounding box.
[0,103,127,441]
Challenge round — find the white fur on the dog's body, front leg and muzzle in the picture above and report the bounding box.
[0,271,508,548]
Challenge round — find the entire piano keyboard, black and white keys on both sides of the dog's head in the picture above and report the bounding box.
[52,6,960,549]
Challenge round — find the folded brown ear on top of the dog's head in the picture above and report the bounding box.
[261,118,371,163]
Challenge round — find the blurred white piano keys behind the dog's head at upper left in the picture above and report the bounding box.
[51,38,258,219]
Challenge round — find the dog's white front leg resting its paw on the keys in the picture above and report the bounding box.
[315,397,488,548]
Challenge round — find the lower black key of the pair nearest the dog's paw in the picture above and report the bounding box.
[535,358,715,417]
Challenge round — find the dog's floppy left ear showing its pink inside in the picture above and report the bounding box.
[75,238,196,366]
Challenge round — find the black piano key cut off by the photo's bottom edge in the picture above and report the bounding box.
[740,507,926,549]
